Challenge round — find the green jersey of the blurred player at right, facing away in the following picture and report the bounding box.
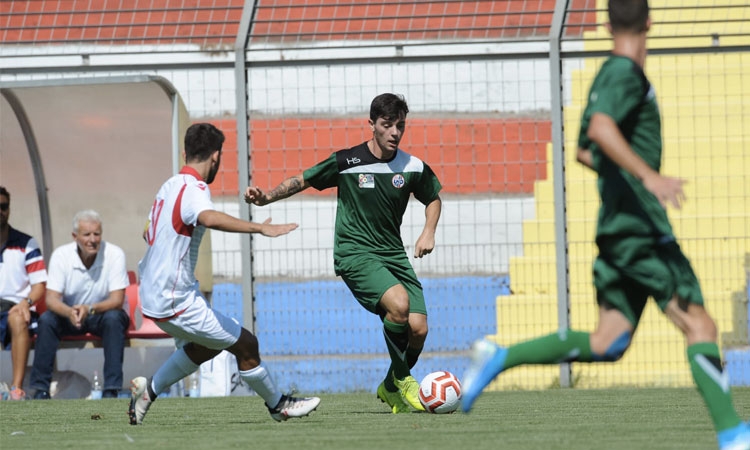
[578,56,672,239]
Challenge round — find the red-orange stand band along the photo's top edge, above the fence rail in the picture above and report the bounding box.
[0,0,595,46]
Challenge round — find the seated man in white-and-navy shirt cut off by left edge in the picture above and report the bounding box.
[0,186,47,400]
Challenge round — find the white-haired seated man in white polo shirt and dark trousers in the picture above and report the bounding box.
[30,210,130,399]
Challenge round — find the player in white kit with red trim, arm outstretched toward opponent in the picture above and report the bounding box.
[128,123,320,425]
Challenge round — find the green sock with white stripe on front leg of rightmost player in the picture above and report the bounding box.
[687,342,741,431]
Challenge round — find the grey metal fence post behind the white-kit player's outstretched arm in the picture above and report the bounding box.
[234,0,258,333]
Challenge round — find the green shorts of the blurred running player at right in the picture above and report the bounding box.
[594,236,703,327]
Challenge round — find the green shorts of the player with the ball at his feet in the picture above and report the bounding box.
[334,253,427,315]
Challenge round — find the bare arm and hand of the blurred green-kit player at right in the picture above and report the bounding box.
[587,113,685,209]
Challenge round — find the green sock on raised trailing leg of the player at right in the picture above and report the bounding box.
[503,330,592,370]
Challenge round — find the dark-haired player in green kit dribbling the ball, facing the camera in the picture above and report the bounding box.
[245,94,442,414]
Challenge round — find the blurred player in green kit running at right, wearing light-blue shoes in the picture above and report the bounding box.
[462,0,750,450]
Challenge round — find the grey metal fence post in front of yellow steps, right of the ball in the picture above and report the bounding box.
[549,0,572,387]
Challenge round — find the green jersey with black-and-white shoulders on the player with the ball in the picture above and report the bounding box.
[303,142,442,259]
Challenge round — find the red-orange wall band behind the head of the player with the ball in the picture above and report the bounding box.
[209,118,551,196]
